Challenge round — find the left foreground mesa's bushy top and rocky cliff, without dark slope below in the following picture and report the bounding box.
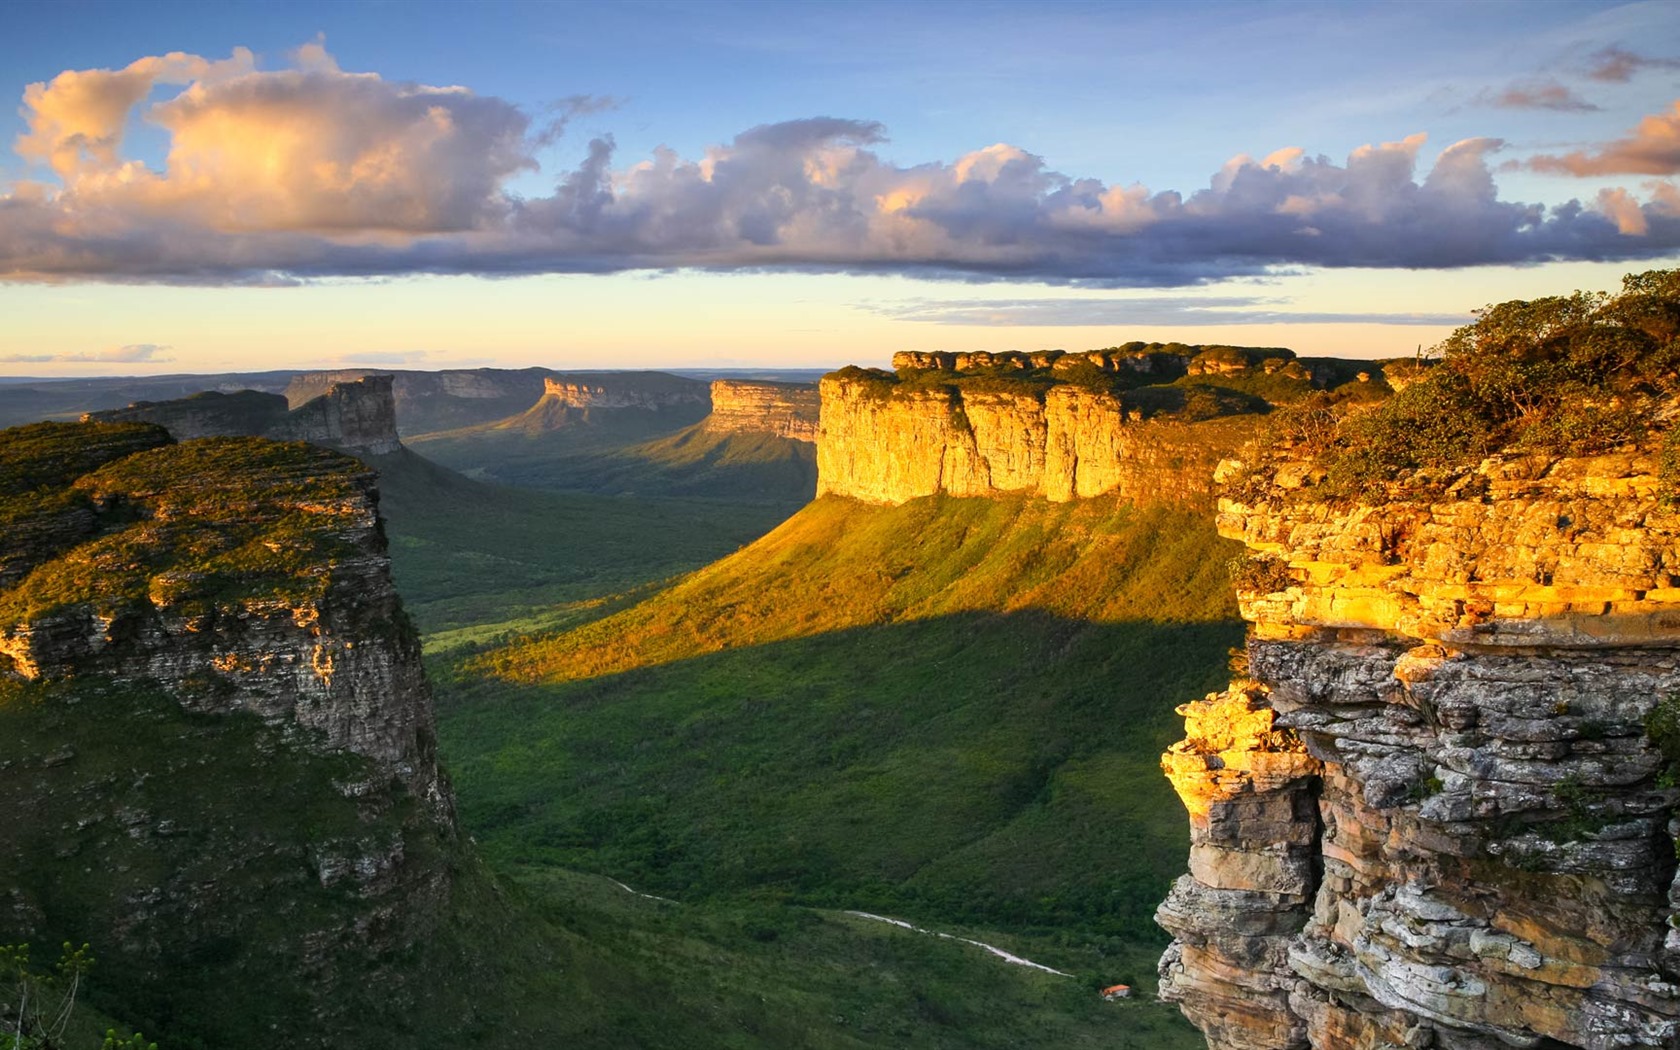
[0,423,452,809]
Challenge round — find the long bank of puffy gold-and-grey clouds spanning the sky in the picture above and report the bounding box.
[0,44,1680,287]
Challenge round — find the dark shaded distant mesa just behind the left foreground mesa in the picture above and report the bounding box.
[82,376,402,455]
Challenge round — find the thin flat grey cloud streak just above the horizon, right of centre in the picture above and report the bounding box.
[858,296,1473,328]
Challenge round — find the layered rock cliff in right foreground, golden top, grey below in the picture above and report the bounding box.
[1159,455,1680,1050]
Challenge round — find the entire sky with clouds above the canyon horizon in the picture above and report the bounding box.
[0,0,1680,376]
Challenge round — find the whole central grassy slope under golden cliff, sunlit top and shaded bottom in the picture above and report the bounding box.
[440,499,1242,1014]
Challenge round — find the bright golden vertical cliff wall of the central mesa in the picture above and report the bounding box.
[816,376,1253,507]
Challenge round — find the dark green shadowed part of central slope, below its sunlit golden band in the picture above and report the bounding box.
[438,612,1243,946]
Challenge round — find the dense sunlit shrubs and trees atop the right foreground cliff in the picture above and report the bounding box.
[1280,270,1680,501]
